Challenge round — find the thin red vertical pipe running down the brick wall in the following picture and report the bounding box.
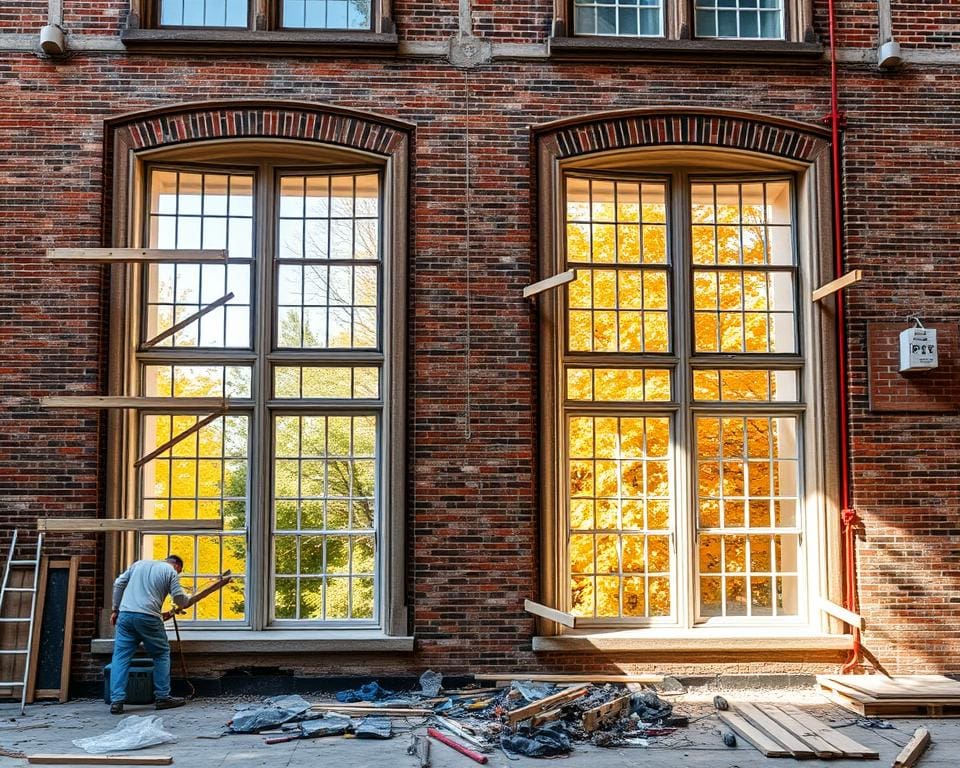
[827,0,860,673]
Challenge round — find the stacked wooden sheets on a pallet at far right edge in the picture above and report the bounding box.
[817,675,960,717]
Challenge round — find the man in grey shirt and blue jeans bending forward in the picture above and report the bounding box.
[110,555,190,715]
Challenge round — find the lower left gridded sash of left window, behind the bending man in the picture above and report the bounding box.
[140,414,249,622]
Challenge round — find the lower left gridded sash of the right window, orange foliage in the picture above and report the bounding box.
[567,416,673,618]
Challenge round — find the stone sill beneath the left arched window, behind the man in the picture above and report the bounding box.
[90,629,413,656]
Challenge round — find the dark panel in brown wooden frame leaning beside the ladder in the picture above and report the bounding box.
[27,555,80,704]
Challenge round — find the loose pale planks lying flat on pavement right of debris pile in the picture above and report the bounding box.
[717,702,880,760]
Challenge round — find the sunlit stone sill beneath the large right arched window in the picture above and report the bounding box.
[533,629,853,654]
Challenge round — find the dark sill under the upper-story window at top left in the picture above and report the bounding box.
[120,29,398,56]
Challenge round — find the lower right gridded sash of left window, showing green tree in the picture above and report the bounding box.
[273,415,378,622]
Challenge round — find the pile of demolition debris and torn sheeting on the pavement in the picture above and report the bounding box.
[228,670,688,765]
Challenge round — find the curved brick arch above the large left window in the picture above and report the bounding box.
[114,104,409,155]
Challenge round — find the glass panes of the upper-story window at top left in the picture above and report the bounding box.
[157,0,373,30]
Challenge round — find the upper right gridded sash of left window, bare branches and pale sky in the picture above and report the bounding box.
[277,174,380,349]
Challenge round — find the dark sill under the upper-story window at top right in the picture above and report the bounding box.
[550,36,823,61]
